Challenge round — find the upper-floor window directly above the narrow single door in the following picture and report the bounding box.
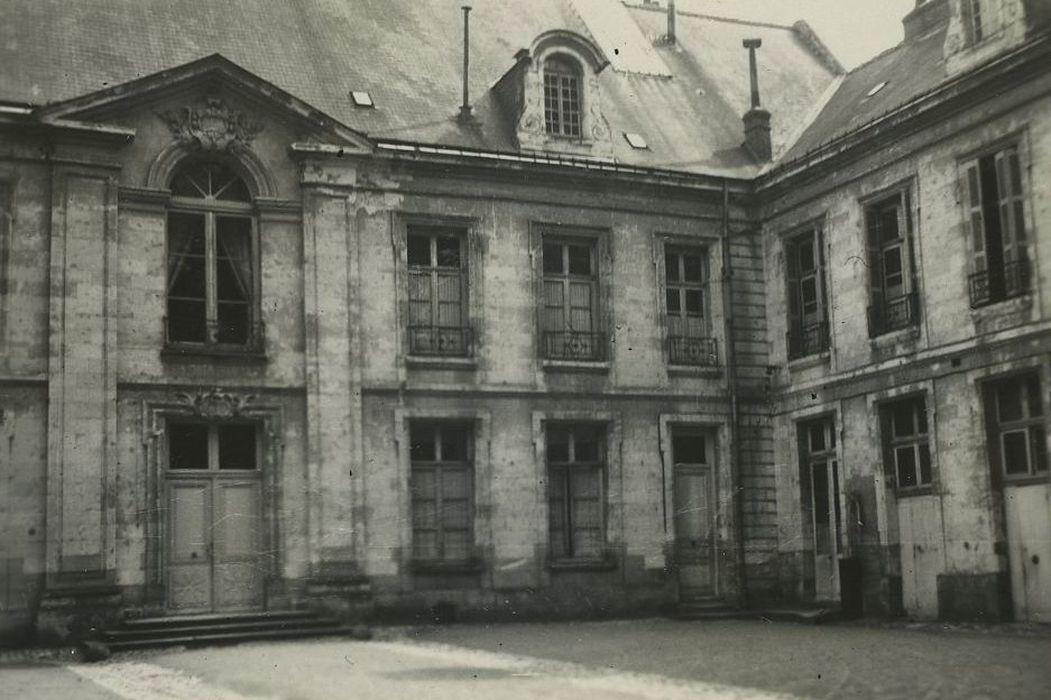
[664,247,719,365]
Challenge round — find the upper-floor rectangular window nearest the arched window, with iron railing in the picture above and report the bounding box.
[407,225,472,357]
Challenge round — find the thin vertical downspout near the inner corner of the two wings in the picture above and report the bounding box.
[722,180,747,608]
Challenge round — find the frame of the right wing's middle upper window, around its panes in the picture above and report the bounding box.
[862,188,920,337]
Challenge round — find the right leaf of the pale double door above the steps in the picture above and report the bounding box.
[212,479,262,610]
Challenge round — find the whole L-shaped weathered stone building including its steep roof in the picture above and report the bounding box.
[0,0,1051,636]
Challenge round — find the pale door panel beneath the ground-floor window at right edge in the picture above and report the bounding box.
[1004,483,1051,622]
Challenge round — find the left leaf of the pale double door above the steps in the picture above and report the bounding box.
[168,480,212,611]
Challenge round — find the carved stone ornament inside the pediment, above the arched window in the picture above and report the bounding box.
[158,97,263,151]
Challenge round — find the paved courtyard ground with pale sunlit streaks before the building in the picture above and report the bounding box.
[0,620,1051,700]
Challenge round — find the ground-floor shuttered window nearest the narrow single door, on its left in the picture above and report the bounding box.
[547,425,605,559]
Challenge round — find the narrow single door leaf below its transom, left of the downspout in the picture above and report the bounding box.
[674,468,715,596]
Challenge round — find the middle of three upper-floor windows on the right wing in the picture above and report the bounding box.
[865,192,919,336]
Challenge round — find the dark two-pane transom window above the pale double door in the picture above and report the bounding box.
[166,419,259,471]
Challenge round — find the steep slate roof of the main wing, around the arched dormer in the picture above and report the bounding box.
[0,0,840,177]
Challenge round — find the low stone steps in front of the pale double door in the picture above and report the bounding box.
[100,611,369,652]
